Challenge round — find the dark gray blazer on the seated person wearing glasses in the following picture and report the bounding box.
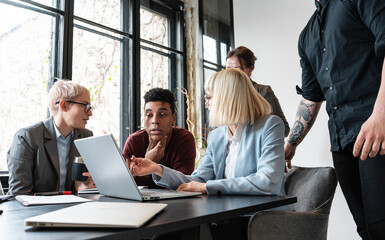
[7,117,92,195]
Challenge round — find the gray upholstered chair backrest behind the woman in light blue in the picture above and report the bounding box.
[285,166,337,214]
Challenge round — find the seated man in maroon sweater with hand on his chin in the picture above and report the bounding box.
[123,88,196,188]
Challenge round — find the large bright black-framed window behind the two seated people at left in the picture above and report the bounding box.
[0,0,185,170]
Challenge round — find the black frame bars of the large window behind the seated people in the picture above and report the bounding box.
[0,0,187,186]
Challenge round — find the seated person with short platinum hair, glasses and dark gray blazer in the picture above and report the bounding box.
[7,80,94,195]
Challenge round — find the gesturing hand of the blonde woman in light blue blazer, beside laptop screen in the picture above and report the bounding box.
[130,156,163,177]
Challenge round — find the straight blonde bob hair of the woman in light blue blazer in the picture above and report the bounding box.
[205,69,271,127]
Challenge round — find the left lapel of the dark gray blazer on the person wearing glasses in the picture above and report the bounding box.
[44,117,60,181]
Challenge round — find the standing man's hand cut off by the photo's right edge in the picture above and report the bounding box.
[353,113,385,160]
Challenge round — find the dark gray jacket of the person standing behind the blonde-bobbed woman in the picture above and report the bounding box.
[251,80,290,137]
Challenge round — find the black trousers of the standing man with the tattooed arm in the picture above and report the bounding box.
[332,143,385,240]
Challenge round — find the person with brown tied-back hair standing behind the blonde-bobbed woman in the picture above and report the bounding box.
[226,46,290,137]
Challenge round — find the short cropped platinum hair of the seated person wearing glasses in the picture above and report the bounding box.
[48,79,88,115]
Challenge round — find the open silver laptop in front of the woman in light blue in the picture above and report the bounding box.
[74,134,201,201]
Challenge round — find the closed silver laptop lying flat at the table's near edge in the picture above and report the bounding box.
[24,202,167,228]
